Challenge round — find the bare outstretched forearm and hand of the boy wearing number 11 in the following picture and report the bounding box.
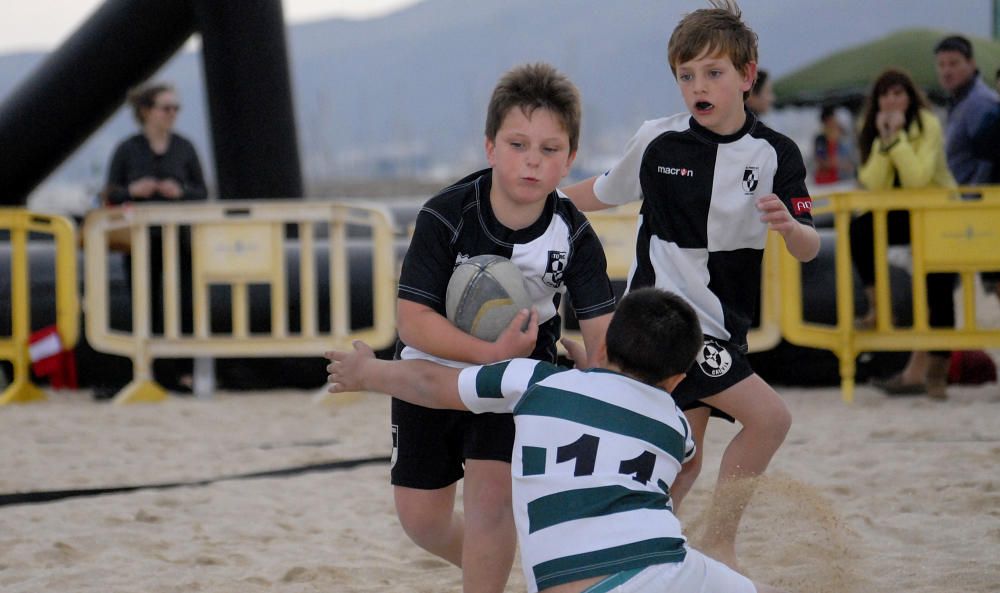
[325,340,468,410]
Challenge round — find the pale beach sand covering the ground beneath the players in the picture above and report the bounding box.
[0,384,1000,593]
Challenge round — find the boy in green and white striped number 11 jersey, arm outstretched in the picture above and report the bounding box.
[327,288,775,593]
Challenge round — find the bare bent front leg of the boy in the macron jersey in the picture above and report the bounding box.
[702,375,792,570]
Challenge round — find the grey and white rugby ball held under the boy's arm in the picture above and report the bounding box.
[445,255,531,342]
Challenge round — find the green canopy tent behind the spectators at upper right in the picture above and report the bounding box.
[774,29,1000,111]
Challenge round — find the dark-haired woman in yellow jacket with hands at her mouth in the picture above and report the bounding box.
[851,69,955,399]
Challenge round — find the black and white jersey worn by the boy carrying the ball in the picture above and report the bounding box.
[398,169,615,362]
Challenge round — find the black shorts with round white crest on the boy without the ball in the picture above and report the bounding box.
[671,336,753,422]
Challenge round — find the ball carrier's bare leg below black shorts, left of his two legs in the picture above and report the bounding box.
[393,484,464,566]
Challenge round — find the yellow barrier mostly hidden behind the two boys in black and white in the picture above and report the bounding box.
[563,205,784,352]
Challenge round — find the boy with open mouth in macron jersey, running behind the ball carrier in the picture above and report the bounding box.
[565,0,819,567]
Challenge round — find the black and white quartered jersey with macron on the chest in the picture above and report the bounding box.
[594,111,812,348]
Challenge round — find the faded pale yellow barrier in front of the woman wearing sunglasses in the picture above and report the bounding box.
[84,200,396,403]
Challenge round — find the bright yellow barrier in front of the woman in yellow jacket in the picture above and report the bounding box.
[780,187,1000,402]
